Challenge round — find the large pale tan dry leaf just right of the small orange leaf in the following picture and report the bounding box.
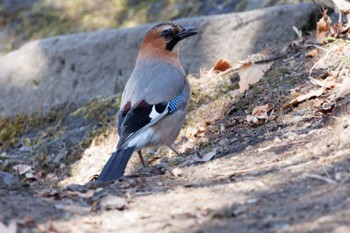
[238,62,273,93]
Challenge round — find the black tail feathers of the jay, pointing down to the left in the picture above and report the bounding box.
[97,147,135,181]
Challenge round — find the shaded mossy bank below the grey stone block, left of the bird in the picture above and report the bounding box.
[0,95,120,175]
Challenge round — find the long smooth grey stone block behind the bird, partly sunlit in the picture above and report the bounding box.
[0,4,315,116]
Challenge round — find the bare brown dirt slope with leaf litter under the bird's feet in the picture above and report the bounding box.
[0,30,350,233]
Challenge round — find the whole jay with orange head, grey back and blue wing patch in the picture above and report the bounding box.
[97,22,198,181]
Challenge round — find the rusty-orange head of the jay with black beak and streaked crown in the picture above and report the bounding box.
[140,22,198,60]
